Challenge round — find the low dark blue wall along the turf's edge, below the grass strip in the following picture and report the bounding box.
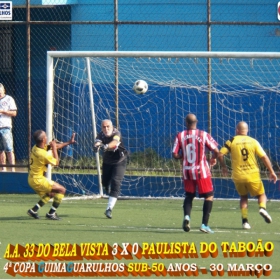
[0,172,280,199]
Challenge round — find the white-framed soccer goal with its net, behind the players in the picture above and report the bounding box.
[46,51,280,199]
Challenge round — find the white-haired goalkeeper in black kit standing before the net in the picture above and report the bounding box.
[93,119,128,219]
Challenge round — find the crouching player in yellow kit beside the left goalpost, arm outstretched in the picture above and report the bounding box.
[27,130,75,220]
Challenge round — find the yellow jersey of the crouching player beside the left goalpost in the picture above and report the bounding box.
[28,145,56,178]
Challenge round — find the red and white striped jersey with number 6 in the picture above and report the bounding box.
[173,129,218,180]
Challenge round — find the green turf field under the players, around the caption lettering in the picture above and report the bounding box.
[0,195,280,279]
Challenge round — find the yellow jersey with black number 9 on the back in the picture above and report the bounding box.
[220,135,266,182]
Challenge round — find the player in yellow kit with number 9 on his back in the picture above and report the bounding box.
[218,121,277,229]
